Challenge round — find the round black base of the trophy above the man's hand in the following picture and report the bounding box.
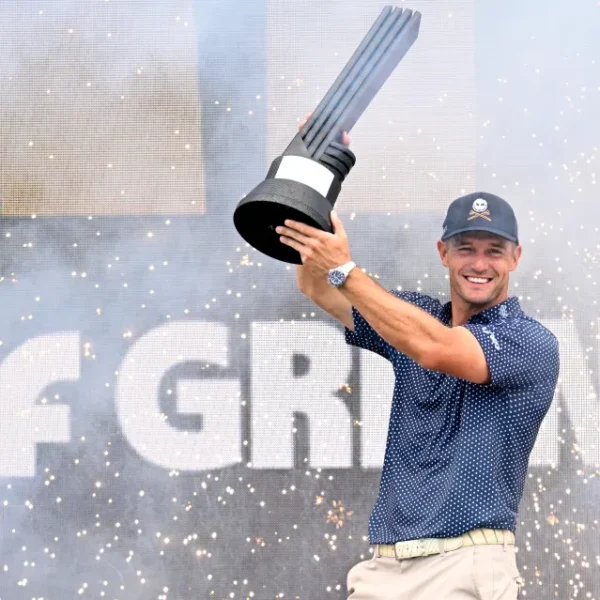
[233,179,333,265]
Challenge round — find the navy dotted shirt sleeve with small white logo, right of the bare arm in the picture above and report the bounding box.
[463,319,560,387]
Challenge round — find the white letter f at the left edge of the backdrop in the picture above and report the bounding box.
[0,331,80,477]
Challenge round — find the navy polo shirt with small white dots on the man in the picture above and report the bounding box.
[345,290,559,544]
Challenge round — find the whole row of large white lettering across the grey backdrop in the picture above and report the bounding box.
[0,320,600,477]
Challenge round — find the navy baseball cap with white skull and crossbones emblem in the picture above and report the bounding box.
[442,192,519,244]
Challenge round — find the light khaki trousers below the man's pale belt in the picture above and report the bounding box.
[347,545,522,600]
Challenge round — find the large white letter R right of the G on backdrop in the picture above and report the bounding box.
[252,322,352,469]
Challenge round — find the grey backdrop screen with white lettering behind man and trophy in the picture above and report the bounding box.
[0,0,600,600]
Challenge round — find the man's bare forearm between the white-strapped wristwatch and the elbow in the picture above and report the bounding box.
[339,268,450,366]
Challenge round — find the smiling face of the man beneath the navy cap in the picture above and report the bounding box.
[438,231,522,309]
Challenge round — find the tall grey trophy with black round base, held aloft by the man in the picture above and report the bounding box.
[233,6,421,264]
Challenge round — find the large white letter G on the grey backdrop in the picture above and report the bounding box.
[115,321,242,471]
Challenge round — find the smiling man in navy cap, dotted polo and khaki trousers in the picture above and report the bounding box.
[277,192,559,600]
